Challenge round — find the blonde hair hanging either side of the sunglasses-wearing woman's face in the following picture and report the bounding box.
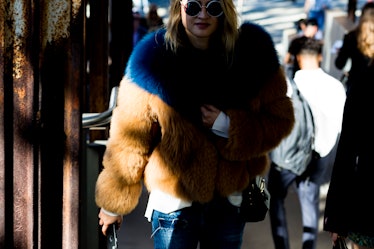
[165,0,238,57]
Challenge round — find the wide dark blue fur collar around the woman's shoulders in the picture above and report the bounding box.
[125,22,279,111]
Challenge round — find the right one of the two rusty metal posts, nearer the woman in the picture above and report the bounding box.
[39,0,86,249]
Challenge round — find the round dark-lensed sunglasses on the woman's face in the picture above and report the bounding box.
[180,0,223,17]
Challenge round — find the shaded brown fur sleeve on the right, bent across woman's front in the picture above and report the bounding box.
[219,68,295,160]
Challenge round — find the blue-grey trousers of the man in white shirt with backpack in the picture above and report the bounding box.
[268,161,320,249]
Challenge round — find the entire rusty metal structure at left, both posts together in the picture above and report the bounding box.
[0,0,85,249]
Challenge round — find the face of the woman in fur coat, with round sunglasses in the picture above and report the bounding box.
[180,0,223,49]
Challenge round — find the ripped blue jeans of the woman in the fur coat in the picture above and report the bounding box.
[151,198,245,249]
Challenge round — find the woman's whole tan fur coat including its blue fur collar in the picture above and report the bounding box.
[96,23,294,214]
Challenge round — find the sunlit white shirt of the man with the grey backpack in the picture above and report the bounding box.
[294,68,346,157]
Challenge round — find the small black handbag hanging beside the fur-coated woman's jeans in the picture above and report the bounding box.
[240,176,270,222]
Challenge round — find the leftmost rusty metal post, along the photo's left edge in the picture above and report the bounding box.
[0,1,36,248]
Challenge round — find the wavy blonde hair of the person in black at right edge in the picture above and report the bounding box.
[357,2,374,58]
